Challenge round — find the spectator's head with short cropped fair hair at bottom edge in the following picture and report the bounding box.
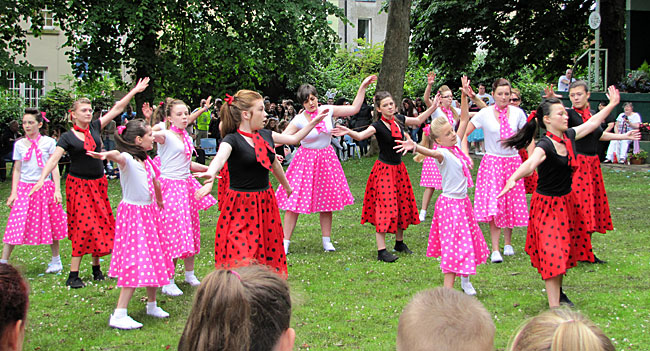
[397,288,496,351]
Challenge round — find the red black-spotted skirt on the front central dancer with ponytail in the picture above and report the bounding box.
[214,187,287,277]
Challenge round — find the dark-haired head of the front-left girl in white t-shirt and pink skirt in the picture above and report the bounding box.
[115,118,153,161]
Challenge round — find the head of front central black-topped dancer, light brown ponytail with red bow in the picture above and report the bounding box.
[219,90,264,137]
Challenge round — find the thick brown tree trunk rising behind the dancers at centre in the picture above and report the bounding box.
[377,0,412,106]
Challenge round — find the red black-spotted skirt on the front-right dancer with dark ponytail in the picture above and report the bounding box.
[526,193,594,280]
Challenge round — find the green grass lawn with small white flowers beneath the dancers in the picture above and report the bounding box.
[0,157,650,350]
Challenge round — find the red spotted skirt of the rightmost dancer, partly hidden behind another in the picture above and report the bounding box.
[572,154,614,234]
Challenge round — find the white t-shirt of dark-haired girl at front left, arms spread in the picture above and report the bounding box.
[118,152,152,206]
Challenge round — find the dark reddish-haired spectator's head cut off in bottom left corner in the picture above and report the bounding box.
[0,263,29,351]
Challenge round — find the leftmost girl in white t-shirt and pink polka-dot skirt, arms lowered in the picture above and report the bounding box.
[0,108,68,273]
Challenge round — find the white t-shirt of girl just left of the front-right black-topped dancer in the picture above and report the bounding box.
[470,106,526,156]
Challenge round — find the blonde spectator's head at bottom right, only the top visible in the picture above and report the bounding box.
[508,308,615,351]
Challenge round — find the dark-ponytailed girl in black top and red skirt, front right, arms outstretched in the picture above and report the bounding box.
[499,86,619,307]
